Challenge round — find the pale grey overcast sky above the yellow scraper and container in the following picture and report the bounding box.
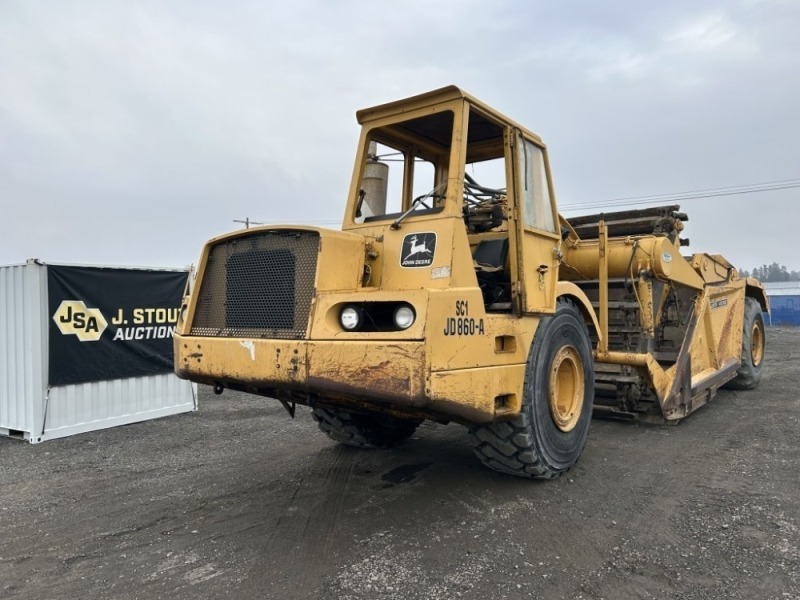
[0,0,800,270]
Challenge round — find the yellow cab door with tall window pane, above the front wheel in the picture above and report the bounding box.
[506,130,561,314]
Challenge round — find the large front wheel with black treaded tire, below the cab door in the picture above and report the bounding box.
[470,299,594,479]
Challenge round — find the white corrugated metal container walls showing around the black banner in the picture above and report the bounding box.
[0,261,197,443]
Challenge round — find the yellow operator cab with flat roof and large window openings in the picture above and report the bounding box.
[344,87,559,312]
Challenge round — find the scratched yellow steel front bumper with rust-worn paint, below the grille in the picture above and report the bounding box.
[174,334,525,424]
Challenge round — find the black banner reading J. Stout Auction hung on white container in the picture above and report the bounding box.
[47,265,188,386]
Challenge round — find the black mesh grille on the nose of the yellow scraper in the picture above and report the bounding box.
[192,231,319,339]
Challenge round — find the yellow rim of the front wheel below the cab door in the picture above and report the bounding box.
[550,346,584,432]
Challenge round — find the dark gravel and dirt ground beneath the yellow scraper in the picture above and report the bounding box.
[0,329,800,600]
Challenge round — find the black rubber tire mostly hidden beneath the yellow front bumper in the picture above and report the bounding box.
[311,407,422,448]
